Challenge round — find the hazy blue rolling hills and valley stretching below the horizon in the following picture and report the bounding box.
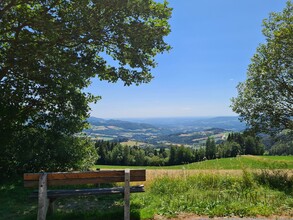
[84,117,243,146]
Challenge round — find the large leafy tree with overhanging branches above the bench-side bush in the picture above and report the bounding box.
[0,0,171,175]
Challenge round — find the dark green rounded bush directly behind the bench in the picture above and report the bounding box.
[0,129,97,175]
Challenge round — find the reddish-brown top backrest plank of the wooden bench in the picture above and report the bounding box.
[23,170,146,187]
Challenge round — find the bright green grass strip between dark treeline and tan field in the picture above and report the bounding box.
[95,156,293,170]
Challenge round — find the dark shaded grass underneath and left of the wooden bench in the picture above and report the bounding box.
[0,178,140,220]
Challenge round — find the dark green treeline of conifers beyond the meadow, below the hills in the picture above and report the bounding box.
[95,133,264,166]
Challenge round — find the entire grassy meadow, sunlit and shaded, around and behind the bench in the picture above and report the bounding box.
[0,156,293,220]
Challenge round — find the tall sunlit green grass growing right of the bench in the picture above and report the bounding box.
[132,171,293,218]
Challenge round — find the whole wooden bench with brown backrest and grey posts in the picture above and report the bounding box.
[24,170,146,220]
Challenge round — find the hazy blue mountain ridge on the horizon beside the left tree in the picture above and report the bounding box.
[87,117,156,130]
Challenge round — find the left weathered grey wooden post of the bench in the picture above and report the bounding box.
[38,173,49,220]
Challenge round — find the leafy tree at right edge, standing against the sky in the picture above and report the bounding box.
[232,1,293,132]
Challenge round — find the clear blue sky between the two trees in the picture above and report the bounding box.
[89,0,286,118]
